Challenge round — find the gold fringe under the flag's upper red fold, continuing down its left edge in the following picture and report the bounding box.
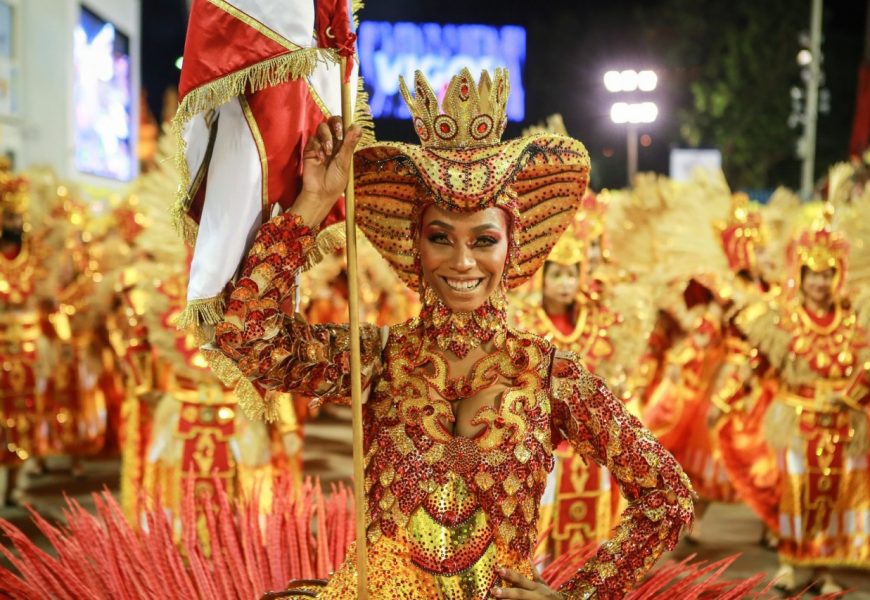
[171,48,340,244]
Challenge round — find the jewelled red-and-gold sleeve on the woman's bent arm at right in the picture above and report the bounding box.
[552,353,693,599]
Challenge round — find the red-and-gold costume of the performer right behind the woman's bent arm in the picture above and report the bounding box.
[511,194,649,559]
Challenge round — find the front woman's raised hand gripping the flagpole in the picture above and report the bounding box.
[290,117,362,229]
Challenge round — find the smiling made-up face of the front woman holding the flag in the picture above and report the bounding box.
[419,205,509,312]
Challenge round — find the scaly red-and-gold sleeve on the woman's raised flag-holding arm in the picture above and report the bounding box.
[215,213,381,401]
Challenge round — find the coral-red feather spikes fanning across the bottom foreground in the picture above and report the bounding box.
[0,478,840,600]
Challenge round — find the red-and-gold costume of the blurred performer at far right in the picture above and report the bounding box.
[721,201,870,568]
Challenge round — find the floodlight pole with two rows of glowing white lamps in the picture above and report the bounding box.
[604,69,659,186]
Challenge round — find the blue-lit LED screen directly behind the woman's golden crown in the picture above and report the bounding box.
[357,21,526,121]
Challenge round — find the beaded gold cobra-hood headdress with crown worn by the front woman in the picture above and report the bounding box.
[354,69,589,290]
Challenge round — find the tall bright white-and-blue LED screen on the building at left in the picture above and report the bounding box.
[73,7,134,181]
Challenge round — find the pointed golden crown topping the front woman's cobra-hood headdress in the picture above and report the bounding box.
[399,68,510,149]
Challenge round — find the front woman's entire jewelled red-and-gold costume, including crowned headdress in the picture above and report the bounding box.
[213,70,692,598]
